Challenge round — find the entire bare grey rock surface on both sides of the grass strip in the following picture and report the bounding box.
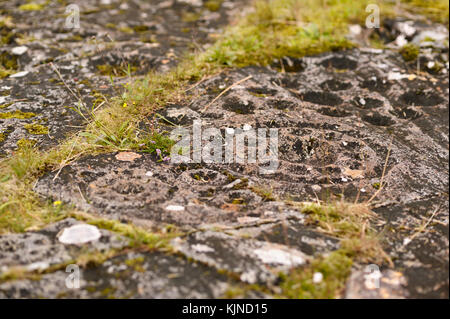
[0,0,449,298]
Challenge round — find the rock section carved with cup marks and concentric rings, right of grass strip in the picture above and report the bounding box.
[32,46,448,297]
